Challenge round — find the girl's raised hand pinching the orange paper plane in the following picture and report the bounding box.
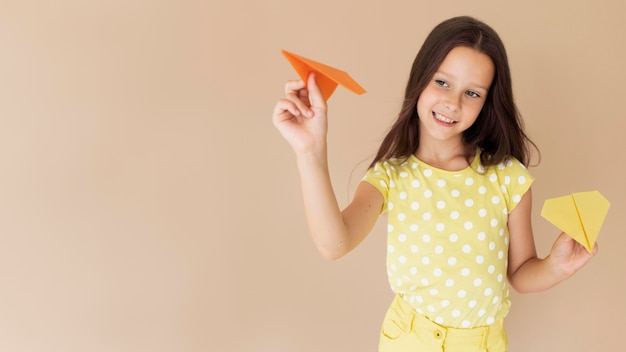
[272,73,328,154]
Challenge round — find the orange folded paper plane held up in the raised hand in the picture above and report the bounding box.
[281,50,365,100]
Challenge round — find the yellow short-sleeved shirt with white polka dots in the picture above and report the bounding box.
[363,151,534,328]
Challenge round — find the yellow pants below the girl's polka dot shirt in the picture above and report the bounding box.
[378,295,508,352]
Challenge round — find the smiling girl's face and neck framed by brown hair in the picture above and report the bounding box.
[417,46,494,145]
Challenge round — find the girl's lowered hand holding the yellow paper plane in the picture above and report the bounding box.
[550,232,598,277]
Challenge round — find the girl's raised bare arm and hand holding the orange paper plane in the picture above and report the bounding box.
[273,74,383,260]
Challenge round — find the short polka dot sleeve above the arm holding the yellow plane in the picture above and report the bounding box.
[496,159,535,214]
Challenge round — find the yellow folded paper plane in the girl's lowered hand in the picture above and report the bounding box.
[541,191,611,252]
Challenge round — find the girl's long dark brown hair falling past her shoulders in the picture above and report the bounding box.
[370,16,538,167]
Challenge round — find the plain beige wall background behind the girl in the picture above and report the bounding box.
[0,0,626,352]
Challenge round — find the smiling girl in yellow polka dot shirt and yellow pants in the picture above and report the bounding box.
[273,17,597,352]
